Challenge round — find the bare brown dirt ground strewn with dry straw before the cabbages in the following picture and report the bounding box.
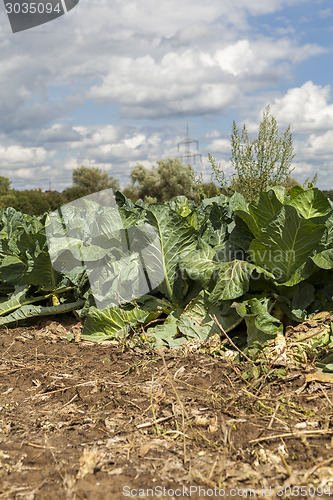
[0,319,333,500]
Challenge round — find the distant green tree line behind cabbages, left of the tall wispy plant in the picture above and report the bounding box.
[0,158,215,215]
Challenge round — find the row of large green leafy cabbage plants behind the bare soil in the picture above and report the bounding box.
[0,186,333,371]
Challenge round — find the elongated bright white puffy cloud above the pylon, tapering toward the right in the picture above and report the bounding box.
[86,38,322,118]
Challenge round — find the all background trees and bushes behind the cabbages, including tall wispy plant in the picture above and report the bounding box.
[0,106,322,215]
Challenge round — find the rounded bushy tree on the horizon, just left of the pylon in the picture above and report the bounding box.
[128,158,197,203]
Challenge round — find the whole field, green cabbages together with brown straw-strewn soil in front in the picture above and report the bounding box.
[0,187,333,500]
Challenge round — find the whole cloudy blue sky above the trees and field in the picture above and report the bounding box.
[0,0,333,191]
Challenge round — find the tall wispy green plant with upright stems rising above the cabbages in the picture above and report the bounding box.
[209,106,295,201]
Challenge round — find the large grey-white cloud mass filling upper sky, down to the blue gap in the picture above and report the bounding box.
[0,0,320,126]
